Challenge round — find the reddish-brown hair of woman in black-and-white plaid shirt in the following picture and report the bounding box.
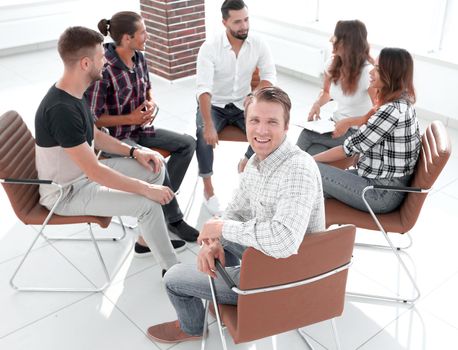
[377,47,416,105]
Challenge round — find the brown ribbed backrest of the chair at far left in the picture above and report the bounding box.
[0,111,40,222]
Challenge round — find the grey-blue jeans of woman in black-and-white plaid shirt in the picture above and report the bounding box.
[317,163,411,214]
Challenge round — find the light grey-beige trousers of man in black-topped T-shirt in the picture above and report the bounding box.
[50,158,178,270]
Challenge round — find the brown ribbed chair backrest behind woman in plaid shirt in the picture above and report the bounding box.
[399,120,452,232]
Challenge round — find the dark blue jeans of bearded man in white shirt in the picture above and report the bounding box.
[196,103,254,177]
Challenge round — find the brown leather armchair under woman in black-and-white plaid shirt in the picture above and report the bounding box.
[325,121,451,303]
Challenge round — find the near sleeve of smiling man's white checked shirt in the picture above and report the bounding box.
[223,157,321,258]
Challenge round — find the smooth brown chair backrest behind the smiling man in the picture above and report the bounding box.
[228,225,355,343]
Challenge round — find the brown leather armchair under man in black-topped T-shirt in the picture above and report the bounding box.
[0,111,131,292]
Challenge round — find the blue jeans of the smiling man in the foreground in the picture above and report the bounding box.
[164,241,246,336]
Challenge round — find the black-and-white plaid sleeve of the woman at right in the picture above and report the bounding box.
[343,103,399,156]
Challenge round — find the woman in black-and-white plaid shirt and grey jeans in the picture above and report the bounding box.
[314,48,421,213]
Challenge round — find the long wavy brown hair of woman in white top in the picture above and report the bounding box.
[328,20,373,95]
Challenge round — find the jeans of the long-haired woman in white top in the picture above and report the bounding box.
[296,129,356,156]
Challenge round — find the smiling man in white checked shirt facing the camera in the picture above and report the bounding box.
[148,87,324,343]
